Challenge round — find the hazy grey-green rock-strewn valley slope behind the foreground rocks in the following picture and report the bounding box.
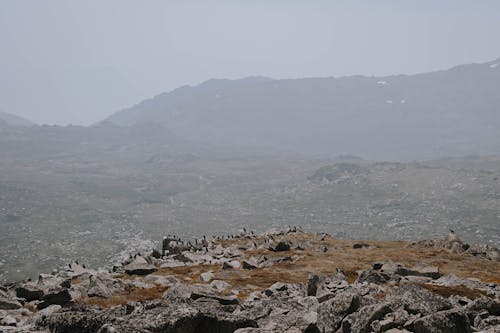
[0,124,500,281]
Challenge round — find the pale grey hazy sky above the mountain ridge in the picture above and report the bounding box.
[0,0,500,125]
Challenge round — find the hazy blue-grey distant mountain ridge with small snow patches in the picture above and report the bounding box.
[107,59,500,159]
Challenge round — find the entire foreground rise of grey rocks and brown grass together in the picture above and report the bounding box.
[0,227,500,333]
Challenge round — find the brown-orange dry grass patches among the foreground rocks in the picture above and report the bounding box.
[75,234,500,306]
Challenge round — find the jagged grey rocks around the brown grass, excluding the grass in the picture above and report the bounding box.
[0,228,500,333]
